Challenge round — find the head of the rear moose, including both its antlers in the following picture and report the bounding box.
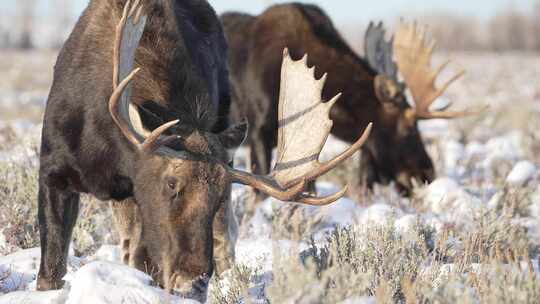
[362,23,476,194]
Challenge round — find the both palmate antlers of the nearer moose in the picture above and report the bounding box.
[109,1,371,205]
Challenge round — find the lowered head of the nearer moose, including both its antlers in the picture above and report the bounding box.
[109,2,371,299]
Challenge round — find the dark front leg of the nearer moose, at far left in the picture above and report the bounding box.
[37,180,80,291]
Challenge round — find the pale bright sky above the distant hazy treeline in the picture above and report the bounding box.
[0,0,540,49]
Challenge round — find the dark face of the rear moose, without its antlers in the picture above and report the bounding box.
[361,81,435,195]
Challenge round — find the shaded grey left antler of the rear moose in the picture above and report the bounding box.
[364,22,398,83]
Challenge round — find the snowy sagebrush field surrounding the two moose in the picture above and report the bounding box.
[0,48,540,304]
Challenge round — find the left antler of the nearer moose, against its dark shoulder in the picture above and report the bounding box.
[109,0,178,151]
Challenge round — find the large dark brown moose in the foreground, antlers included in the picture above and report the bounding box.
[37,0,370,301]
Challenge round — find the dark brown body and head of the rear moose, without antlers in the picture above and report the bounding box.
[221,3,434,192]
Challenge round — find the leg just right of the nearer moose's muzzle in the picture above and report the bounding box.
[213,190,238,275]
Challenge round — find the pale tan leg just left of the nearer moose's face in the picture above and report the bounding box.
[111,198,142,267]
